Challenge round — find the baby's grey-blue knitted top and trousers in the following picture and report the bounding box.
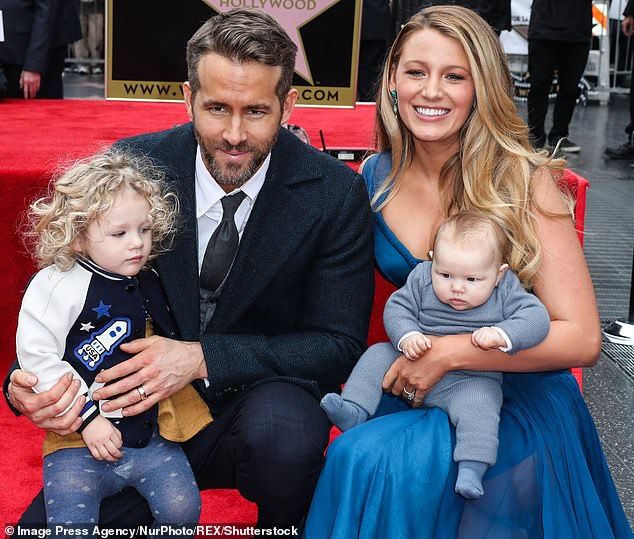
[341,261,550,465]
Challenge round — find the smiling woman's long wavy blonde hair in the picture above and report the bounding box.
[372,6,565,288]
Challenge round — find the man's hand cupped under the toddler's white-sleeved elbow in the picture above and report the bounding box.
[9,369,86,436]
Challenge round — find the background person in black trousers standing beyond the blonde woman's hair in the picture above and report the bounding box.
[527,0,592,153]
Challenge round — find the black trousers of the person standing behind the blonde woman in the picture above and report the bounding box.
[528,39,590,148]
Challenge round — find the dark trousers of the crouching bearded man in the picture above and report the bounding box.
[20,382,330,528]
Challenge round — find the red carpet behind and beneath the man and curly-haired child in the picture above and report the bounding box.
[0,100,376,524]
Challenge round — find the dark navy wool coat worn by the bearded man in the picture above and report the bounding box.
[117,124,374,410]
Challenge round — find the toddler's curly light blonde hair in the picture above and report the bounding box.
[24,150,179,271]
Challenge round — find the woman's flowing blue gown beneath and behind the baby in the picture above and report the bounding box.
[304,154,634,539]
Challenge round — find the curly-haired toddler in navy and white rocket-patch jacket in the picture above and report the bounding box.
[16,151,211,525]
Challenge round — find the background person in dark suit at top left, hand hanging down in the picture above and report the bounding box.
[0,0,81,99]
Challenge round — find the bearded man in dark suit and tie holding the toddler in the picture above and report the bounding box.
[8,10,373,527]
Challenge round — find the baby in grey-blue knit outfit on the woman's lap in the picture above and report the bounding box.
[321,211,550,499]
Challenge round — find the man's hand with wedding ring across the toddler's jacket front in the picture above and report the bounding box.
[92,335,207,416]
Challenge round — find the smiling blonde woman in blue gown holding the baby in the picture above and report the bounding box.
[305,6,632,539]
